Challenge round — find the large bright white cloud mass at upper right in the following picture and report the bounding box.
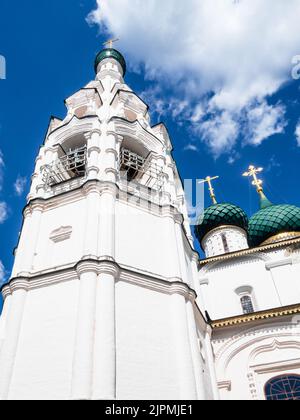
[89,0,300,154]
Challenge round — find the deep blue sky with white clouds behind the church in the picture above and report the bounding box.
[0,0,300,306]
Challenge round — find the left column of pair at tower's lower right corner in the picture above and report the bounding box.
[170,293,197,400]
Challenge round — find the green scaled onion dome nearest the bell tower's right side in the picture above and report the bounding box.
[195,203,248,244]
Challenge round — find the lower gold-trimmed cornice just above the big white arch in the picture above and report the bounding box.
[211,304,300,329]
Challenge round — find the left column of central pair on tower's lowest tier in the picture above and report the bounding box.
[72,264,97,400]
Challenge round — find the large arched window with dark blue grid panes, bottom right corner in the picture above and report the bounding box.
[265,375,300,401]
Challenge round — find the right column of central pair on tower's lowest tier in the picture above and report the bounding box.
[93,270,117,400]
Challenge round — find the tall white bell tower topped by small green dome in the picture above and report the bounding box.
[0,48,216,400]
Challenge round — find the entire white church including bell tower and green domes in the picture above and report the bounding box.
[0,46,300,400]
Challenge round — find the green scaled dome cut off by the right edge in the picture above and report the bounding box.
[248,202,300,247]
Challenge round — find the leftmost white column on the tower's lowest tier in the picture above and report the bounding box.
[0,289,27,400]
